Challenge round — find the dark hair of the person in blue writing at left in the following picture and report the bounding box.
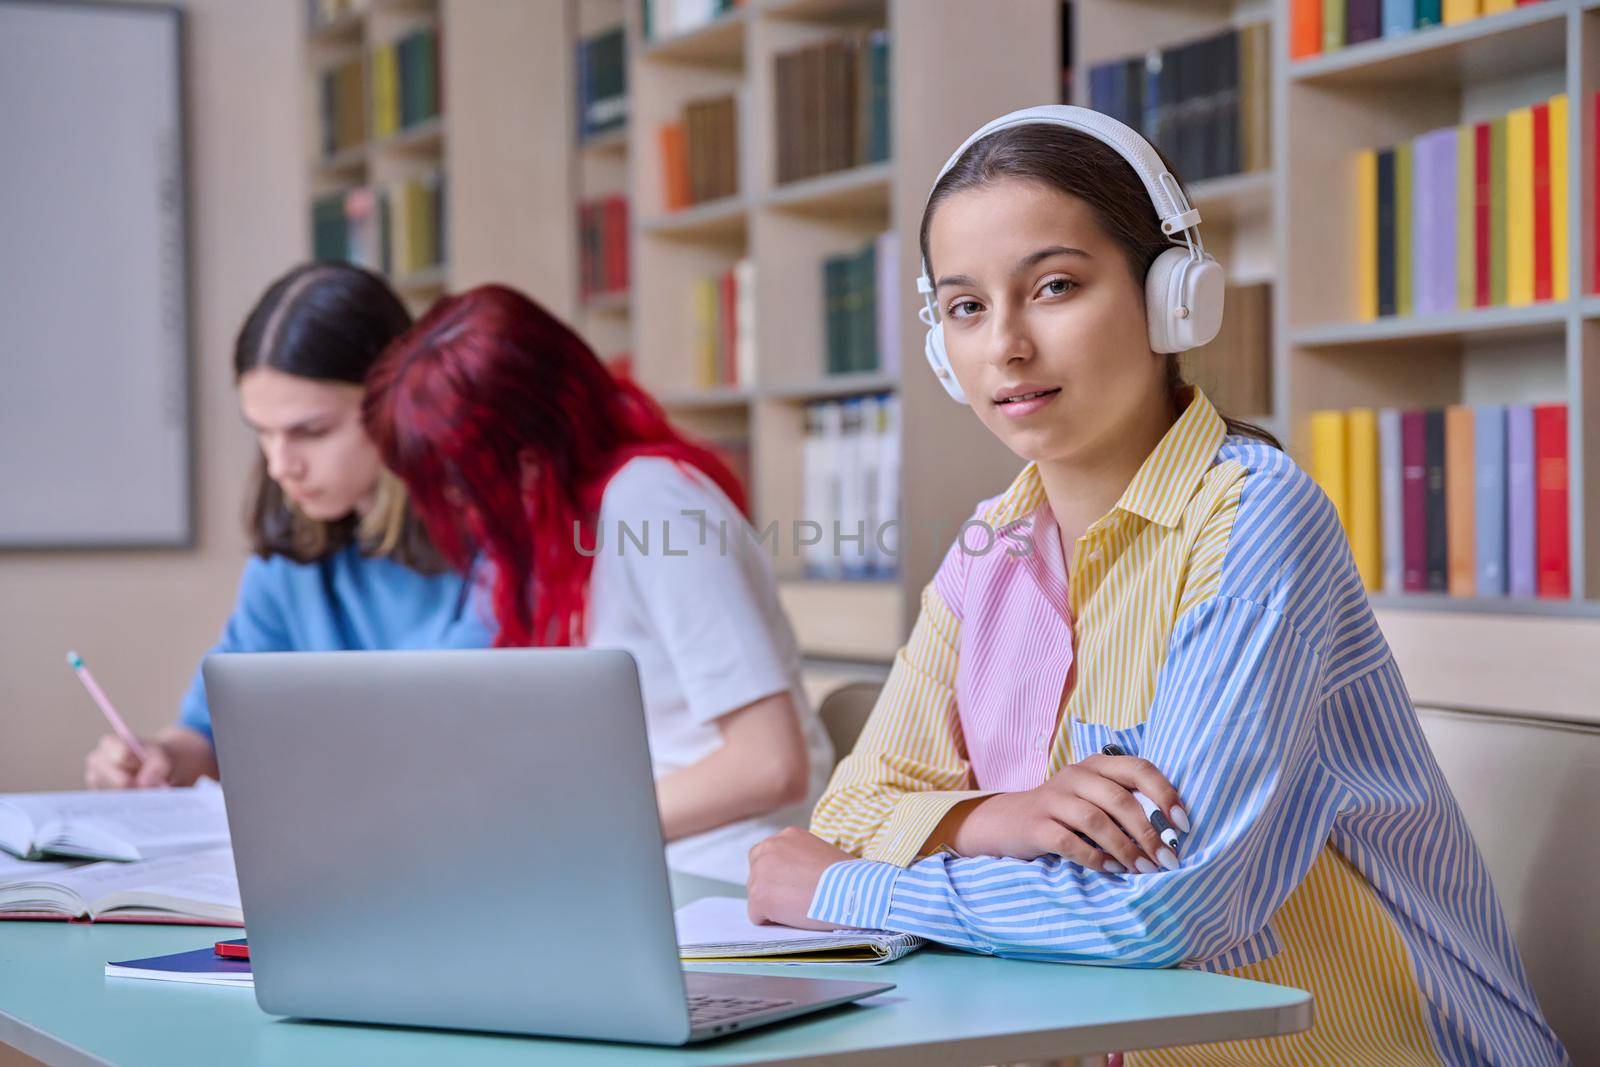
[234,262,446,574]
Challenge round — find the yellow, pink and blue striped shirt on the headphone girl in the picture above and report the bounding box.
[810,390,1568,1064]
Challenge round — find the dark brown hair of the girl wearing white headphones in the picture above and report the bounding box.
[918,125,1283,448]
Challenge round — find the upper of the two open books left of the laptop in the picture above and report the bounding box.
[0,779,227,861]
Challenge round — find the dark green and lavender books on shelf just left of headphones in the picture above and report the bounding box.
[822,230,901,374]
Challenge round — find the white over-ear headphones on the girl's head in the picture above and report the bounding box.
[917,104,1224,403]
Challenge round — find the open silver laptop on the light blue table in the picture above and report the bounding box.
[205,649,893,1045]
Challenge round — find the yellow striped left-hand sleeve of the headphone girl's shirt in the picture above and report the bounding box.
[811,582,992,867]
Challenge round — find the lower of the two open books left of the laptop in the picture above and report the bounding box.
[0,848,245,926]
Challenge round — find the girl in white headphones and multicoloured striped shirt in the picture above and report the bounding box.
[749,106,1566,1064]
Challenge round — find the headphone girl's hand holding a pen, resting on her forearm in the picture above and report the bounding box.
[928,755,1189,873]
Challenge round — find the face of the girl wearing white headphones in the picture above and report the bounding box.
[928,179,1166,462]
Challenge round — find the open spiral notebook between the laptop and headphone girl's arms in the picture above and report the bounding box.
[674,896,926,963]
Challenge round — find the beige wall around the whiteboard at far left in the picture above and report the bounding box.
[0,0,307,792]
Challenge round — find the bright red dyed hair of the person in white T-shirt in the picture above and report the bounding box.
[362,285,746,646]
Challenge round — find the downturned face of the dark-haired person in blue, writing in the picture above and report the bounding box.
[238,366,382,522]
